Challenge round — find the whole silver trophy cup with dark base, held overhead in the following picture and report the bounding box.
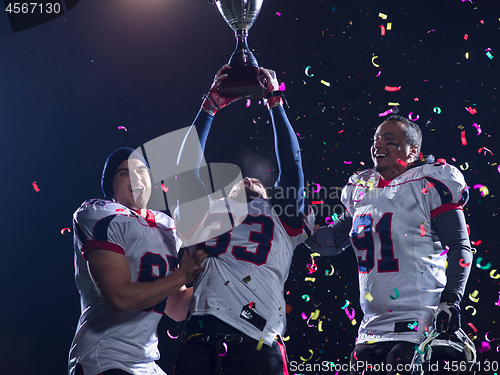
[215,0,264,98]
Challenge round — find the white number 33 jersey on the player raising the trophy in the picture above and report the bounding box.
[181,198,314,345]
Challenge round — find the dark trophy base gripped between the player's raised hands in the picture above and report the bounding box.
[218,66,264,99]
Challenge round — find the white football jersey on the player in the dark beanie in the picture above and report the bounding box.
[69,199,180,375]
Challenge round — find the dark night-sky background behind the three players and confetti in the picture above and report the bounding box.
[0,0,500,374]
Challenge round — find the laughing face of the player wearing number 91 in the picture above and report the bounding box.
[371,120,418,180]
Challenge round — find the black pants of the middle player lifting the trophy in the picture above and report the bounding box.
[174,334,288,375]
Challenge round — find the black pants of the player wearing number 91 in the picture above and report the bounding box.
[351,341,416,375]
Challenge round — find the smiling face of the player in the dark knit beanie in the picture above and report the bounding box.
[113,159,151,213]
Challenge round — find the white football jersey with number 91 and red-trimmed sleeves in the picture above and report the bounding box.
[342,163,468,343]
